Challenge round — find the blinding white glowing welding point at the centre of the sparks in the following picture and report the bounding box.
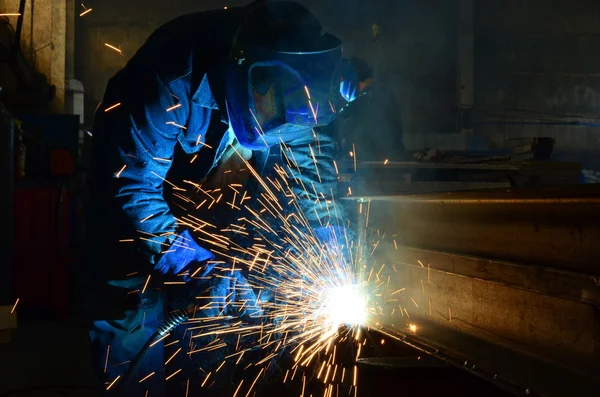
[325,285,367,327]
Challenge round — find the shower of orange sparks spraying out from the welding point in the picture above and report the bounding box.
[108,135,418,397]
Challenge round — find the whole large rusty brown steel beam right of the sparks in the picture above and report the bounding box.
[356,187,600,397]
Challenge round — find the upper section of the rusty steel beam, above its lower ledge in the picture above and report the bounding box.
[354,189,600,274]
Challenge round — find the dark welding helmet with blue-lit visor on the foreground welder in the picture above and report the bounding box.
[225,1,343,149]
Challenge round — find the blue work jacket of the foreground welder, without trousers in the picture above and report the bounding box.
[88,10,345,288]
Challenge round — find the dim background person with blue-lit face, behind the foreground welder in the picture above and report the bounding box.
[336,57,407,162]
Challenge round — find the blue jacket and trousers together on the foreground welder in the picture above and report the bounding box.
[87,3,344,396]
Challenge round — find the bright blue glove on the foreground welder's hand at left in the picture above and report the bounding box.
[154,230,214,281]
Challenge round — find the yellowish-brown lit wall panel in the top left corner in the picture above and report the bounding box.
[0,0,73,113]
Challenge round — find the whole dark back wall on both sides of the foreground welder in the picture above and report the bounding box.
[72,0,600,163]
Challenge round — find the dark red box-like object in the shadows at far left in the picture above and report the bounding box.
[14,186,70,319]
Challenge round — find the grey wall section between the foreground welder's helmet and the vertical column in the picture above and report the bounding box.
[304,0,462,148]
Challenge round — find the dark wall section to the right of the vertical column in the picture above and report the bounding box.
[475,0,600,166]
